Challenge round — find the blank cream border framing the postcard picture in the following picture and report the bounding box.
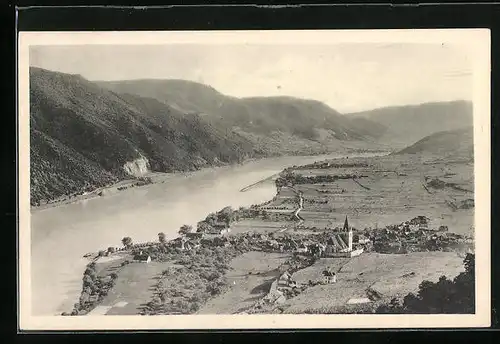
[18,29,491,331]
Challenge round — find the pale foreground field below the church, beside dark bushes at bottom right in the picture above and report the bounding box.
[280,252,464,313]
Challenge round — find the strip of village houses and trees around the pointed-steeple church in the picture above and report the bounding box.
[86,203,473,270]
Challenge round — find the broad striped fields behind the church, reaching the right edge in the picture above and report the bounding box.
[233,155,474,235]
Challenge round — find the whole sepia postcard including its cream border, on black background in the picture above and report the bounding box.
[18,29,491,330]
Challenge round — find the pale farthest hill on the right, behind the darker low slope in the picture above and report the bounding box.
[348,101,473,148]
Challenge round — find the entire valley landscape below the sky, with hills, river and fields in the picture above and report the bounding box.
[30,68,475,316]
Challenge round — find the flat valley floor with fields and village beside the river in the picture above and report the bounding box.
[69,146,474,315]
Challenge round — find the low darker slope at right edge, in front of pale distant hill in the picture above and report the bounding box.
[396,127,474,158]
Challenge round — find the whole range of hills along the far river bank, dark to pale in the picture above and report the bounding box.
[30,67,385,204]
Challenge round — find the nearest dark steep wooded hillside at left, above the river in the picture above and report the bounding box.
[30,68,256,204]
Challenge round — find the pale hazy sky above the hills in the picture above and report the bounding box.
[30,43,472,113]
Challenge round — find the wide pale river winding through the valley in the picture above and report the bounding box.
[31,154,377,315]
